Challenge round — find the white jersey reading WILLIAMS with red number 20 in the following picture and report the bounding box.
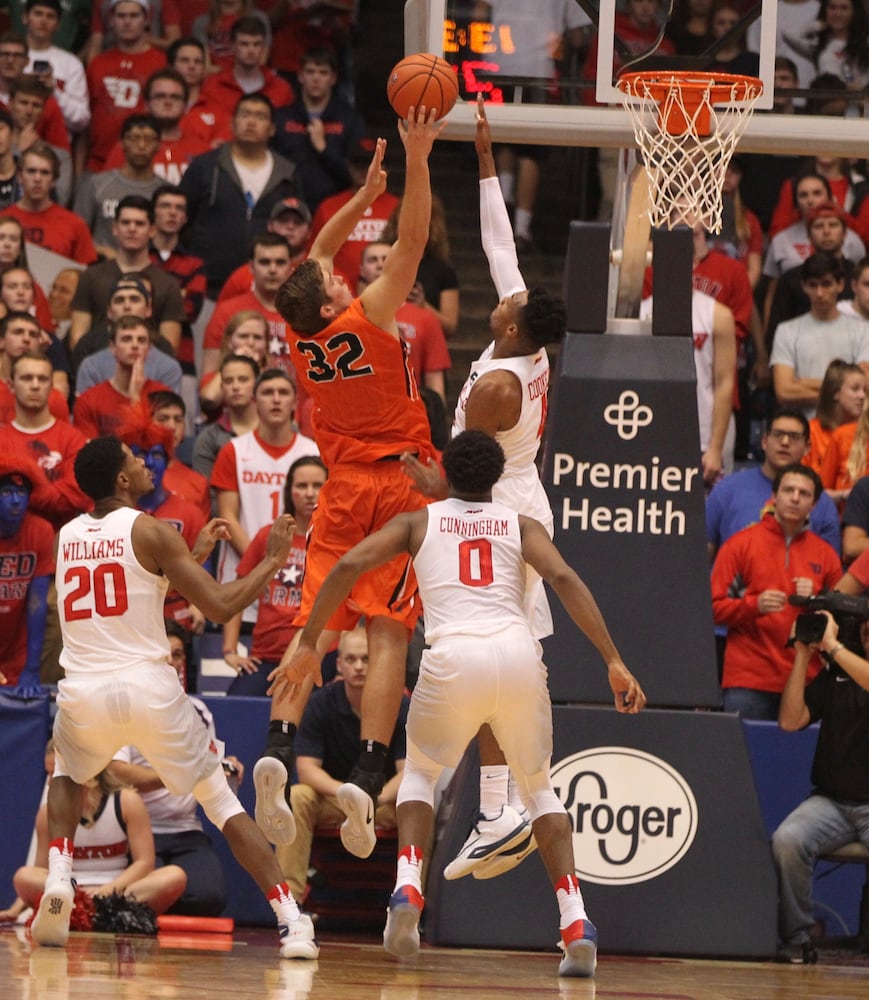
[57,507,169,677]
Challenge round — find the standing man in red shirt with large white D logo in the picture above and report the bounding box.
[84,0,166,171]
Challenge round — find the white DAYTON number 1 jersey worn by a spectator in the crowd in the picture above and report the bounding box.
[217,431,320,622]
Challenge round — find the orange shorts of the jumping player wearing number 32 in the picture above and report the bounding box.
[293,460,428,631]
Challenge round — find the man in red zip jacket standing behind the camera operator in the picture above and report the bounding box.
[712,464,842,721]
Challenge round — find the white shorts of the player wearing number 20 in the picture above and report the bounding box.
[54,663,220,795]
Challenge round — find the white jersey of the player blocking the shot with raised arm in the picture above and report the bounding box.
[453,343,552,537]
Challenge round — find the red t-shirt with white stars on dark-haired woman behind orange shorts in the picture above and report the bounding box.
[237,525,306,660]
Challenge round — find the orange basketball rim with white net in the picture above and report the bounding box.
[616,72,763,233]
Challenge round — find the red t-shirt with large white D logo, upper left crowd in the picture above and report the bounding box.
[85,47,166,172]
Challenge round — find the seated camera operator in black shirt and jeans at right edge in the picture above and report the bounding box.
[772,604,869,964]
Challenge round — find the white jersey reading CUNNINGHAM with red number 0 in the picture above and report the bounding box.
[413,497,529,643]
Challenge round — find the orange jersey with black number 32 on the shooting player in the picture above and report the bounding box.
[289,299,434,469]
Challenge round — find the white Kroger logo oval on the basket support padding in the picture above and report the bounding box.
[551,747,697,885]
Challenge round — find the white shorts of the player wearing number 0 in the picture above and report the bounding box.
[407,625,552,775]
